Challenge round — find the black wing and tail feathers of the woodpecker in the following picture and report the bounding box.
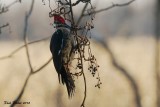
[50,29,75,97]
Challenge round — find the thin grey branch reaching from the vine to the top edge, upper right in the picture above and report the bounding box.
[83,0,135,16]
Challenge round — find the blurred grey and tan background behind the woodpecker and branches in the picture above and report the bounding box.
[0,0,160,107]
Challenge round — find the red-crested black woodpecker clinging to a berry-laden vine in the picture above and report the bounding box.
[50,15,75,97]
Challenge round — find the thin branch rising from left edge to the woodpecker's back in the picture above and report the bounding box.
[0,37,50,60]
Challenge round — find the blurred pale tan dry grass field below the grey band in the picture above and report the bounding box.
[0,36,156,107]
